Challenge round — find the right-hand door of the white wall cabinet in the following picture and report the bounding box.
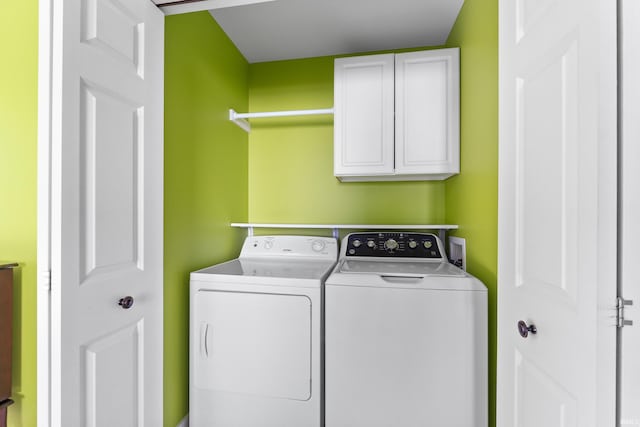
[395,48,460,179]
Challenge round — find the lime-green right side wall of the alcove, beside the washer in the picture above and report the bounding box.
[445,0,498,426]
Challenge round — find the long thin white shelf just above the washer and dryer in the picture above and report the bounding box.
[231,222,458,242]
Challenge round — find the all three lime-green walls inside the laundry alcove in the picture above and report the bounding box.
[164,4,497,426]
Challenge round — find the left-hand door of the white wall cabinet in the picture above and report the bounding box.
[334,54,394,180]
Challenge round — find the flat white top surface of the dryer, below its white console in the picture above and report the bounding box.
[191,258,335,280]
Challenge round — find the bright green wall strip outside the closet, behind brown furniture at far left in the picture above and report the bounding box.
[0,0,38,427]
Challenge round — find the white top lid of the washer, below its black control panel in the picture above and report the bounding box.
[338,259,467,277]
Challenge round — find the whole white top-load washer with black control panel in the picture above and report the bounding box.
[325,232,488,427]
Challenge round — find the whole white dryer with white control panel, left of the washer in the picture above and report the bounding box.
[189,236,338,427]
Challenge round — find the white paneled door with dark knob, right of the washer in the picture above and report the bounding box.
[497,0,617,427]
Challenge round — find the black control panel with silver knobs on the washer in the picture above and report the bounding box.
[343,232,443,258]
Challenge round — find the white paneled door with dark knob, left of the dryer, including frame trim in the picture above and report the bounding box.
[39,0,164,427]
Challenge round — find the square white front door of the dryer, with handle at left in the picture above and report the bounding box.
[192,291,311,400]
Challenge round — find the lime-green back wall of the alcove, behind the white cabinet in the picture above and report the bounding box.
[249,57,445,224]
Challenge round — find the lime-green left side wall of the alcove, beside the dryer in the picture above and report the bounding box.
[164,12,248,427]
